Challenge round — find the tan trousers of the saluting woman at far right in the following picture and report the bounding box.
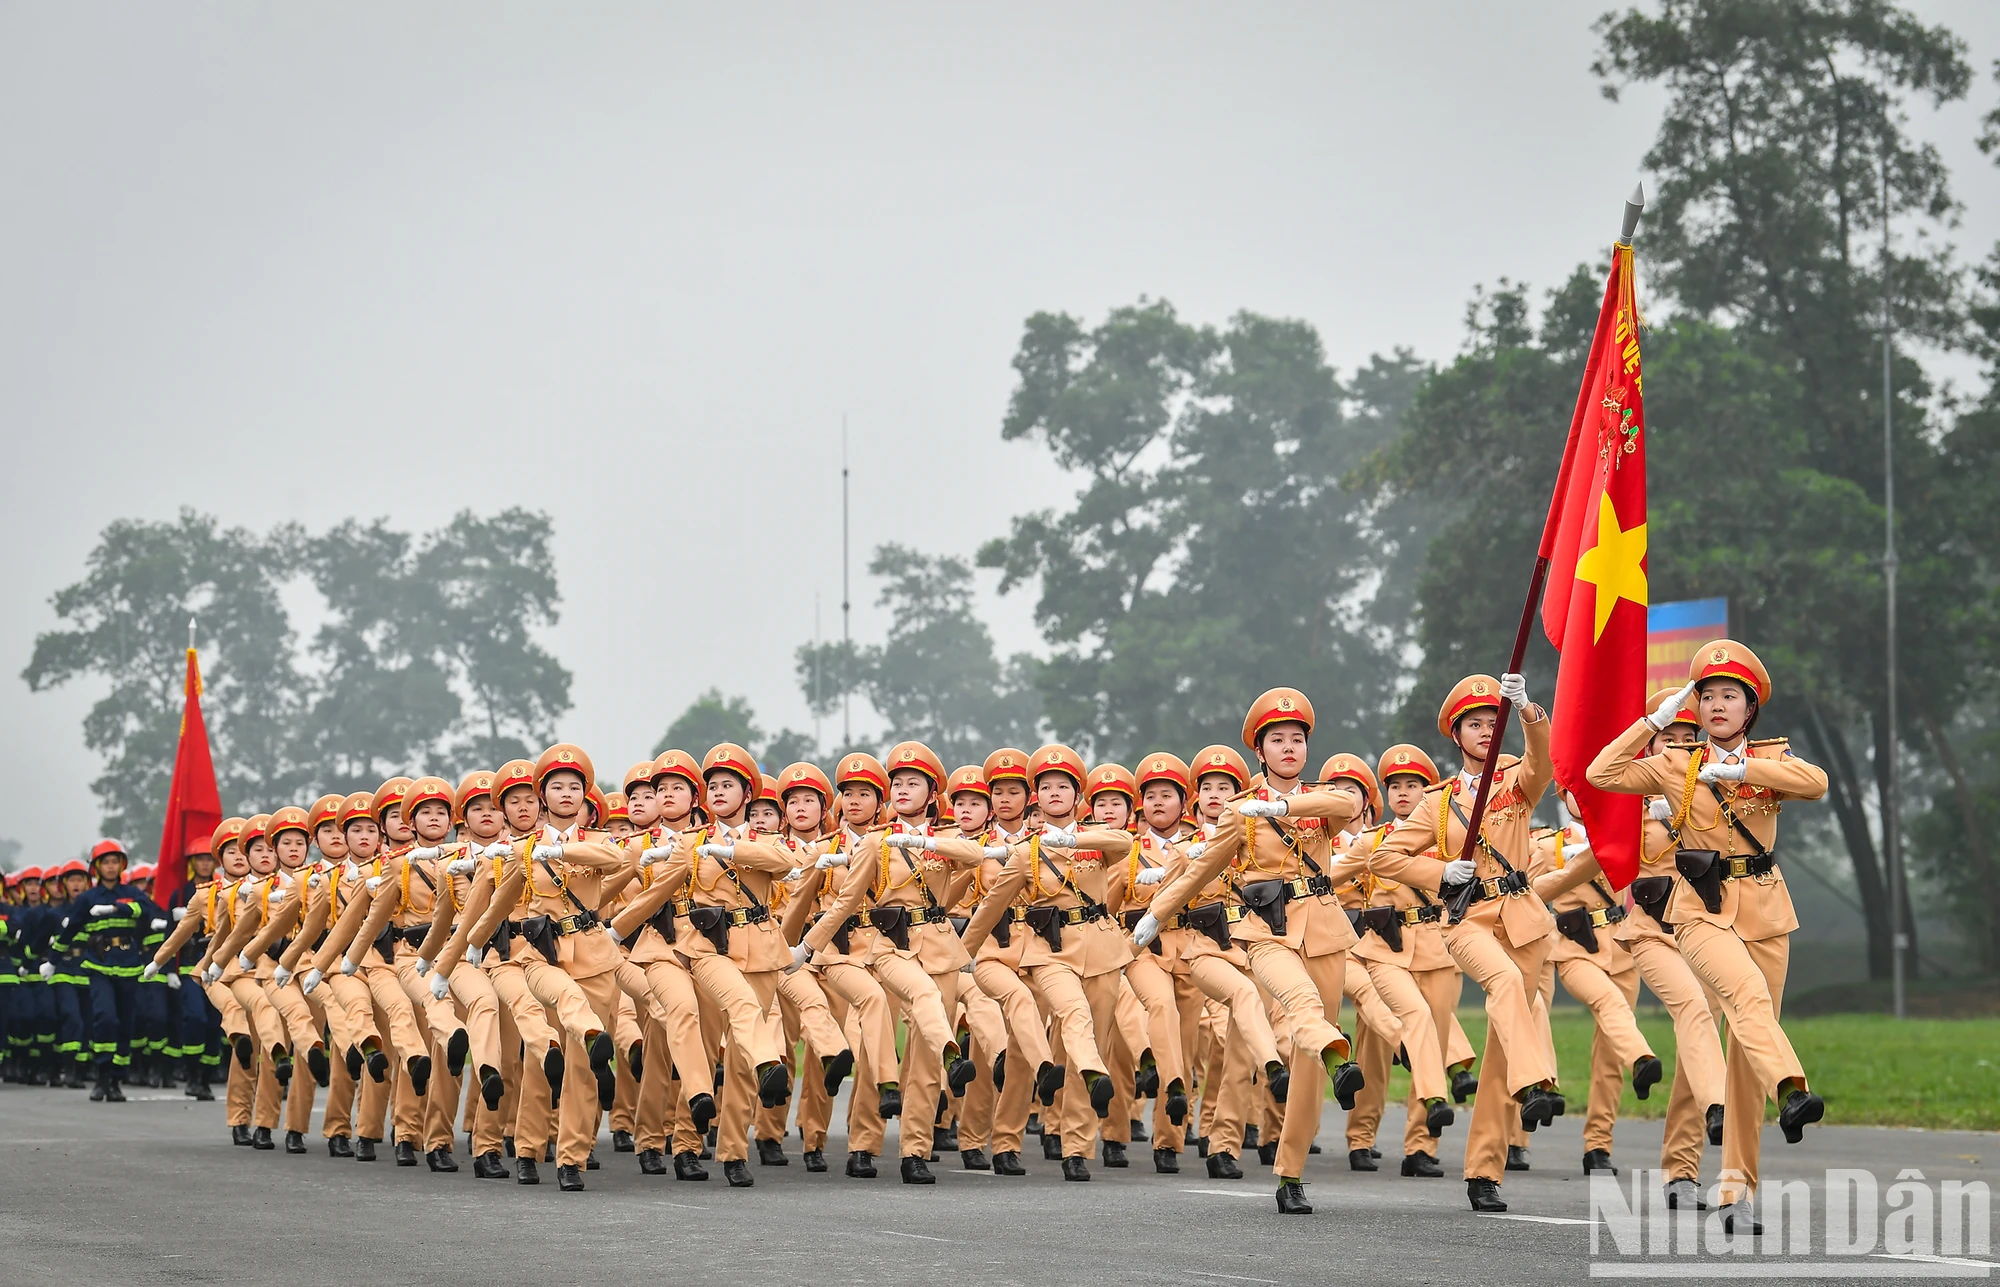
[1674,921,1806,1203]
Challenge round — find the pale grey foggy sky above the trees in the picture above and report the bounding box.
[0,0,2000,861]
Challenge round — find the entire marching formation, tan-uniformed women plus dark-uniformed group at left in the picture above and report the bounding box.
[0,640,1826,1229]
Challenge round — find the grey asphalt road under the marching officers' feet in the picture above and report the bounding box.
[0,1085,2000,1287]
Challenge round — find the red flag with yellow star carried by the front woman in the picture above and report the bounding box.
[1542,246,1646,889]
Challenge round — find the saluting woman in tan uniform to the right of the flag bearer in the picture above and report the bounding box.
[1590,640,1826,1231]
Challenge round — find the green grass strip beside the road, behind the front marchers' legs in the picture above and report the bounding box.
[1350,1005,2000,1131]
